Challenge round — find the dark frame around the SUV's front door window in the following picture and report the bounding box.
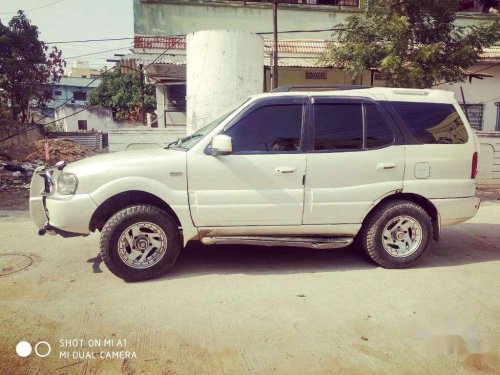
[208,95,308,156]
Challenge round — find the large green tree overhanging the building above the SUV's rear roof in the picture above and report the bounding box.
[320,0,500,88]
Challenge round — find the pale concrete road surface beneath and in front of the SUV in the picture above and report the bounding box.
[0,202,500,374]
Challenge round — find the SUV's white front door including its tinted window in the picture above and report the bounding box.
[187,96,306,227]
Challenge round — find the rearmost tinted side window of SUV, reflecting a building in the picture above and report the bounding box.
[392,102,469,144]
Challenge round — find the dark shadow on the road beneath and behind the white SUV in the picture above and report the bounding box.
[155,224,500,280]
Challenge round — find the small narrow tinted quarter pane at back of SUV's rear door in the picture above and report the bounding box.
[364,102,394,148]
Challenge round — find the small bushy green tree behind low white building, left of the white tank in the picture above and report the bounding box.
[88,69,156,121]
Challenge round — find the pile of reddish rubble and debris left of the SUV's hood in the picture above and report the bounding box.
[0,139,94,190]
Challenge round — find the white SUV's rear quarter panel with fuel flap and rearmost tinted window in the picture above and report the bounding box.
[391,101,477,198]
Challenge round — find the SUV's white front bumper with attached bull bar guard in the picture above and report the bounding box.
[30,168,97,237]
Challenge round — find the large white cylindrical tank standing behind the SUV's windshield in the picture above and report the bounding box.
[186,30,264,134]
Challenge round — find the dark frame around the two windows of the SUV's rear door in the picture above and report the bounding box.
[307,96,398,154]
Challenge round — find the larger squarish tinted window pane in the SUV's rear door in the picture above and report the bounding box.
[314,102,363,151]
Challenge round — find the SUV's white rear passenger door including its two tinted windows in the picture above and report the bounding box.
[303,97,405,224]
